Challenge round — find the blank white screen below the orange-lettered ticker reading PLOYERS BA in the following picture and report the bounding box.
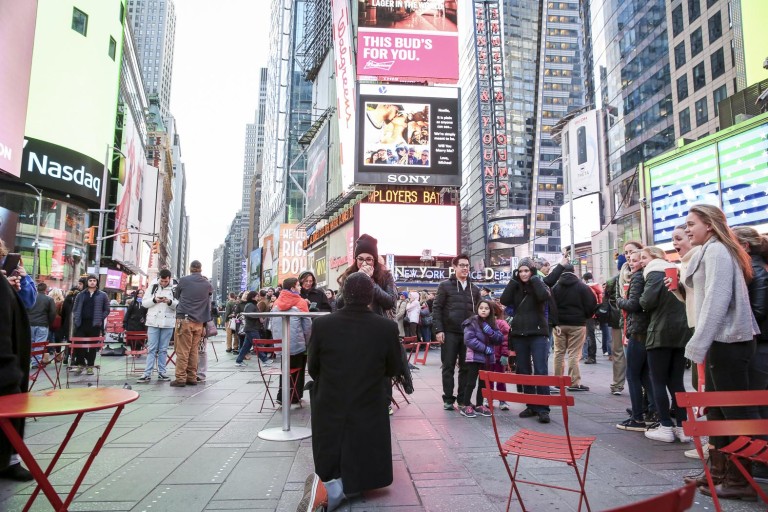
[355,203,459,256]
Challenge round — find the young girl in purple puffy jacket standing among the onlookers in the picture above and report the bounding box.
[457,299,504,418]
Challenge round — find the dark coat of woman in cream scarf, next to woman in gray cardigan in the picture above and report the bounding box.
[640,262,691,350]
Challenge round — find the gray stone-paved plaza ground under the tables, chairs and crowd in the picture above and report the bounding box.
[0,339,765,512]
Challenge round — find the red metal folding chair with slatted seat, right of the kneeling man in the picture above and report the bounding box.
[480,370,595,511]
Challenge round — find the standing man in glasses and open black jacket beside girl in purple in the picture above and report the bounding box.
[432,254,480,411]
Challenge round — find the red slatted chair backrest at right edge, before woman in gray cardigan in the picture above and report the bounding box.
[675,391,768,437]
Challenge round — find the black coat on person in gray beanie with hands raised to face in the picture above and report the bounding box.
[500,270,550,338]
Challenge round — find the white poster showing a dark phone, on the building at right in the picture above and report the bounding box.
[566,110,600,199]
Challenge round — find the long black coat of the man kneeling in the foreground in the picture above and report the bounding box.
[307,305,401,494]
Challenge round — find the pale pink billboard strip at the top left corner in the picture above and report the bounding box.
[0,0,37,177]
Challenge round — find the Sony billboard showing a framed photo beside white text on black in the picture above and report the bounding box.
[355,84,461,186]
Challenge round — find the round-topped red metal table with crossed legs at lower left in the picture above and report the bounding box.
[0,388,139,512]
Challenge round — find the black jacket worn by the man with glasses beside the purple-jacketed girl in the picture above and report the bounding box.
[432,275,480,335]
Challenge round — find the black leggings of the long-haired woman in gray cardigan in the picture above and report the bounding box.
[705,340,759,449]
